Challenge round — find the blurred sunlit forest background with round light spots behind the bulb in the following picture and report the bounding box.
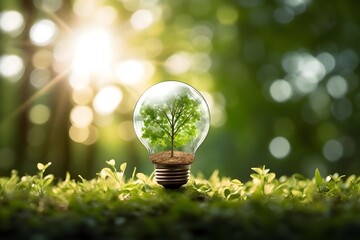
[0,0,360,179]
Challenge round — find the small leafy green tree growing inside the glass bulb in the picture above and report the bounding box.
[140,91,201,157]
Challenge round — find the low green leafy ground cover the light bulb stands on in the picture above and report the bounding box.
[0,160,360,239]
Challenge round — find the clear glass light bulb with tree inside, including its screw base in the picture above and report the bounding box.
[133,81,210,189]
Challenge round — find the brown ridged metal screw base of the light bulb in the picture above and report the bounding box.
[155,164,190,189]
